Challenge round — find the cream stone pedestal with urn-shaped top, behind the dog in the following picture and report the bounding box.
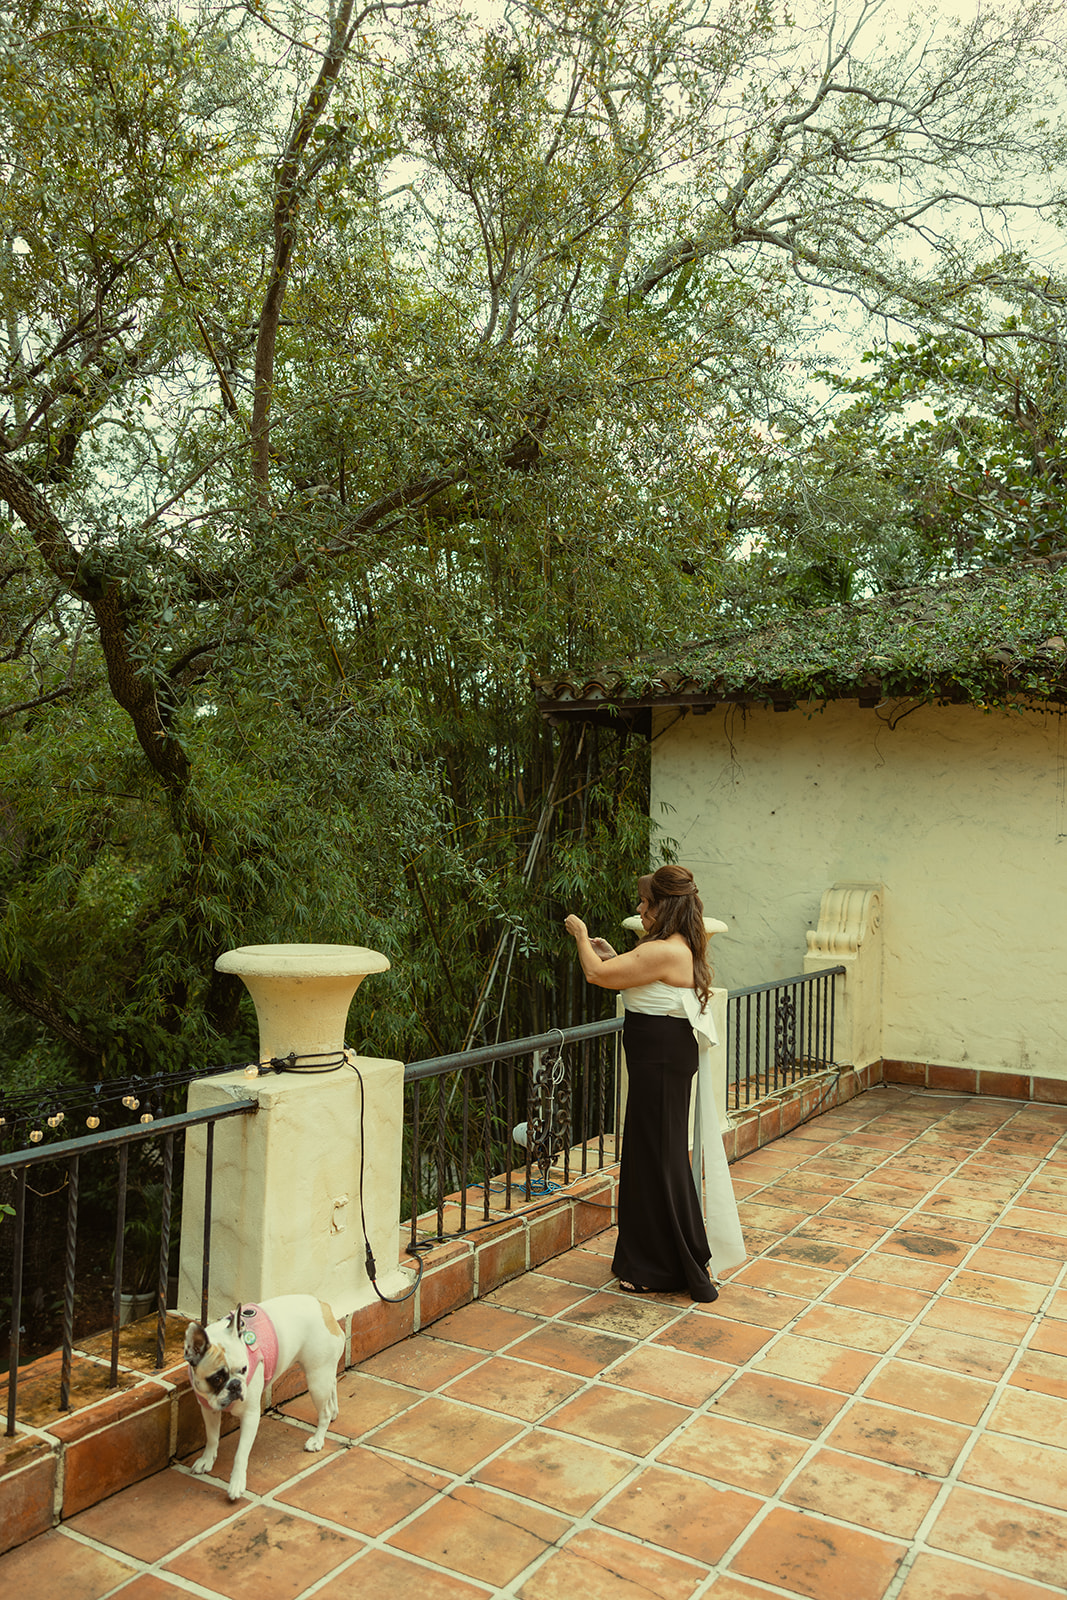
[179,946,410,1317]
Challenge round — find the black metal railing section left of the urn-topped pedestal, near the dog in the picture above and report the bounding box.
[0,1099,258,1437]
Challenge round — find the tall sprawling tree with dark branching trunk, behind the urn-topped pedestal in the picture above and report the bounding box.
[0,0,1062,1072]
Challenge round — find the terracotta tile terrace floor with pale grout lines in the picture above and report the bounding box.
[0,1088,1067,1600]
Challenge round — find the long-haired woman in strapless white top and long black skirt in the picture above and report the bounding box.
[565,866,745,1301]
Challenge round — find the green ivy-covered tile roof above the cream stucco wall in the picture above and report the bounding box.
[539,560,1067,706]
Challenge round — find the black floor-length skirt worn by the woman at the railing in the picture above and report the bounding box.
[611,1011,717,1301]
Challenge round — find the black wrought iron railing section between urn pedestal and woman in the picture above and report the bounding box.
[402,1018,622,1245]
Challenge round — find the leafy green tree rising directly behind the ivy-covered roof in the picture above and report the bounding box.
[737,275,1067,605]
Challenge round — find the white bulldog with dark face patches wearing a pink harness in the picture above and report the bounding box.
[186,1294,344,1499]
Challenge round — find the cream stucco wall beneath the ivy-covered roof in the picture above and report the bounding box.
[653,701,1067,1078]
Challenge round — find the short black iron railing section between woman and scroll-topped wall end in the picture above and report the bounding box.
[726,966,845,1110]
